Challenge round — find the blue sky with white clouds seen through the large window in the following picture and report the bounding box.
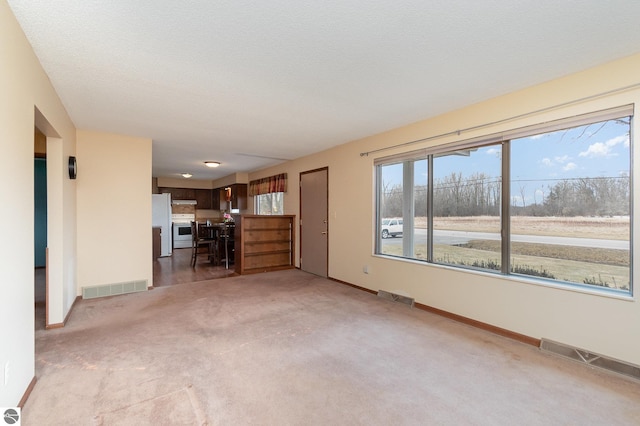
[383,115,630,204]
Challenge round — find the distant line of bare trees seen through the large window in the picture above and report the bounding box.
[381,173,631,217]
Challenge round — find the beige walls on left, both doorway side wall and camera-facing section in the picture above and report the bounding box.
[0,0,152,406]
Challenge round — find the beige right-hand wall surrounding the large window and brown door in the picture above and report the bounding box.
[249,55,640,365]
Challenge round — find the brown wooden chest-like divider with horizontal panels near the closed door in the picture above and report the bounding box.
[234,215,295,274]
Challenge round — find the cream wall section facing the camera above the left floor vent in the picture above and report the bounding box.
[77,130,153,295]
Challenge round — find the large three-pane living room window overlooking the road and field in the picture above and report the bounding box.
[375,107,633,295]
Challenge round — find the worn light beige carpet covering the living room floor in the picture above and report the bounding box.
[23,270,640,425]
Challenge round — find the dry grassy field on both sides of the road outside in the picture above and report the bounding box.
[383,216,630,290]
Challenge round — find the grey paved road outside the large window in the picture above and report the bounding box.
[382,229,629,250]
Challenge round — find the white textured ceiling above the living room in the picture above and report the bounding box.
[8,0,640,179]
